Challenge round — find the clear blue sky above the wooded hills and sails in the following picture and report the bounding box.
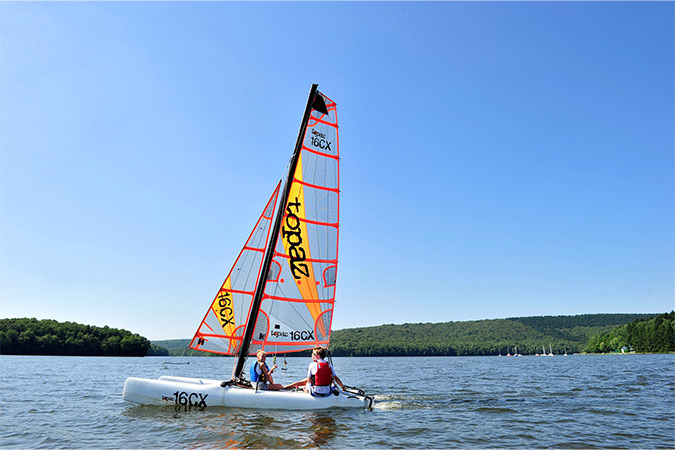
[0,2,675,339]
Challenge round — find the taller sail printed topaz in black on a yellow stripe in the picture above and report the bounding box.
[249,93,340,354]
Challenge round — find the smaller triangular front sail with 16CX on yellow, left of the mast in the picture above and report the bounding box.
[189,182,281,355]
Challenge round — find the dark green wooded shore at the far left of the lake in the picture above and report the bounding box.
[0,319,151,356]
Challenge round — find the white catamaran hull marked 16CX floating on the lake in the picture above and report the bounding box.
[123,376,372,410]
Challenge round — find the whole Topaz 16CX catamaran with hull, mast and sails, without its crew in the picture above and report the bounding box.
[123,84,373,410]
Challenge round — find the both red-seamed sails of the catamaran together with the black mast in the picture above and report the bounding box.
[190,85,340,376]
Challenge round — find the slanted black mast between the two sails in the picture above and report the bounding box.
[232,84,319,380]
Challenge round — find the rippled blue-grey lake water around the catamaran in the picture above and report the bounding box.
[0,355,675,449]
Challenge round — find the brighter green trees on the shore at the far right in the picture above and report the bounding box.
[587,311,675,353]
